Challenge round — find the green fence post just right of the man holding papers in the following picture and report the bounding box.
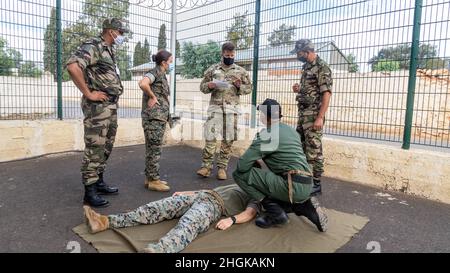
[250,0,261,128]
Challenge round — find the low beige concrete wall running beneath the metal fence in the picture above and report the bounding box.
[0,119,450,204]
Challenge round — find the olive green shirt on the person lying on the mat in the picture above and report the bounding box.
[214,184,260,217]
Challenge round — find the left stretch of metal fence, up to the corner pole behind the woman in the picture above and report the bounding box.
[0,0,171,120]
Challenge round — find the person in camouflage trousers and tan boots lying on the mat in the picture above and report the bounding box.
[84,184,326,253]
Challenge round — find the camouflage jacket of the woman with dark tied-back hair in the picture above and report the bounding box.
[142,65,170,121]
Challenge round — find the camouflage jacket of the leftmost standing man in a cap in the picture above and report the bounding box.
[67,37,123,96]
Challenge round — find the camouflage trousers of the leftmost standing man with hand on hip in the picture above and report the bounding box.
[81,98,117,186]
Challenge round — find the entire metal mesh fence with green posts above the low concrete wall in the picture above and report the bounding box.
[0,0,450,148]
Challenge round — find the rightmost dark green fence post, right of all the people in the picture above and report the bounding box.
[402,0,423,150]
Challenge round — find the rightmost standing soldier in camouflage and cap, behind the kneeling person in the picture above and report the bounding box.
[291,39,333,196]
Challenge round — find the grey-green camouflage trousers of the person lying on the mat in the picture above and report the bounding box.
[108,191,222,253]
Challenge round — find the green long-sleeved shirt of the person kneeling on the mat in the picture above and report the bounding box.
[237,123,310,175]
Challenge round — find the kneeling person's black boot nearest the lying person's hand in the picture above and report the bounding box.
[255,198,289,228]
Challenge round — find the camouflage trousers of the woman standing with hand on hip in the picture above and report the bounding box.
[142,118,167,181]
